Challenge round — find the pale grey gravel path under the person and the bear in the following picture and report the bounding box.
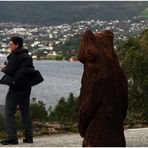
[0,128,148,147]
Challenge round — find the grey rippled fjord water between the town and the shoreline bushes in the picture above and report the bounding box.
[0,58,83,107]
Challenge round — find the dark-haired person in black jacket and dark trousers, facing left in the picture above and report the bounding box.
[1,36,34,145]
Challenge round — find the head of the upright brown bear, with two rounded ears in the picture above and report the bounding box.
[78,30,114,63]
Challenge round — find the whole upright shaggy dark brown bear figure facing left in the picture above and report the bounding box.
[78,30,128,147]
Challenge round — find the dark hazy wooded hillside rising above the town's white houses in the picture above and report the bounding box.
[0,1,148,25]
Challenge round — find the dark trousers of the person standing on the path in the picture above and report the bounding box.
[5,88,32,140]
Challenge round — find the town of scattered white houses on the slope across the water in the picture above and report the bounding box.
[0,17,148,60]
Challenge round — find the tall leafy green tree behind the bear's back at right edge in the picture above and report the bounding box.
[119,29,148,121]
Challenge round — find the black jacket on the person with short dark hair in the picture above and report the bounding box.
[2,48,34,89]
